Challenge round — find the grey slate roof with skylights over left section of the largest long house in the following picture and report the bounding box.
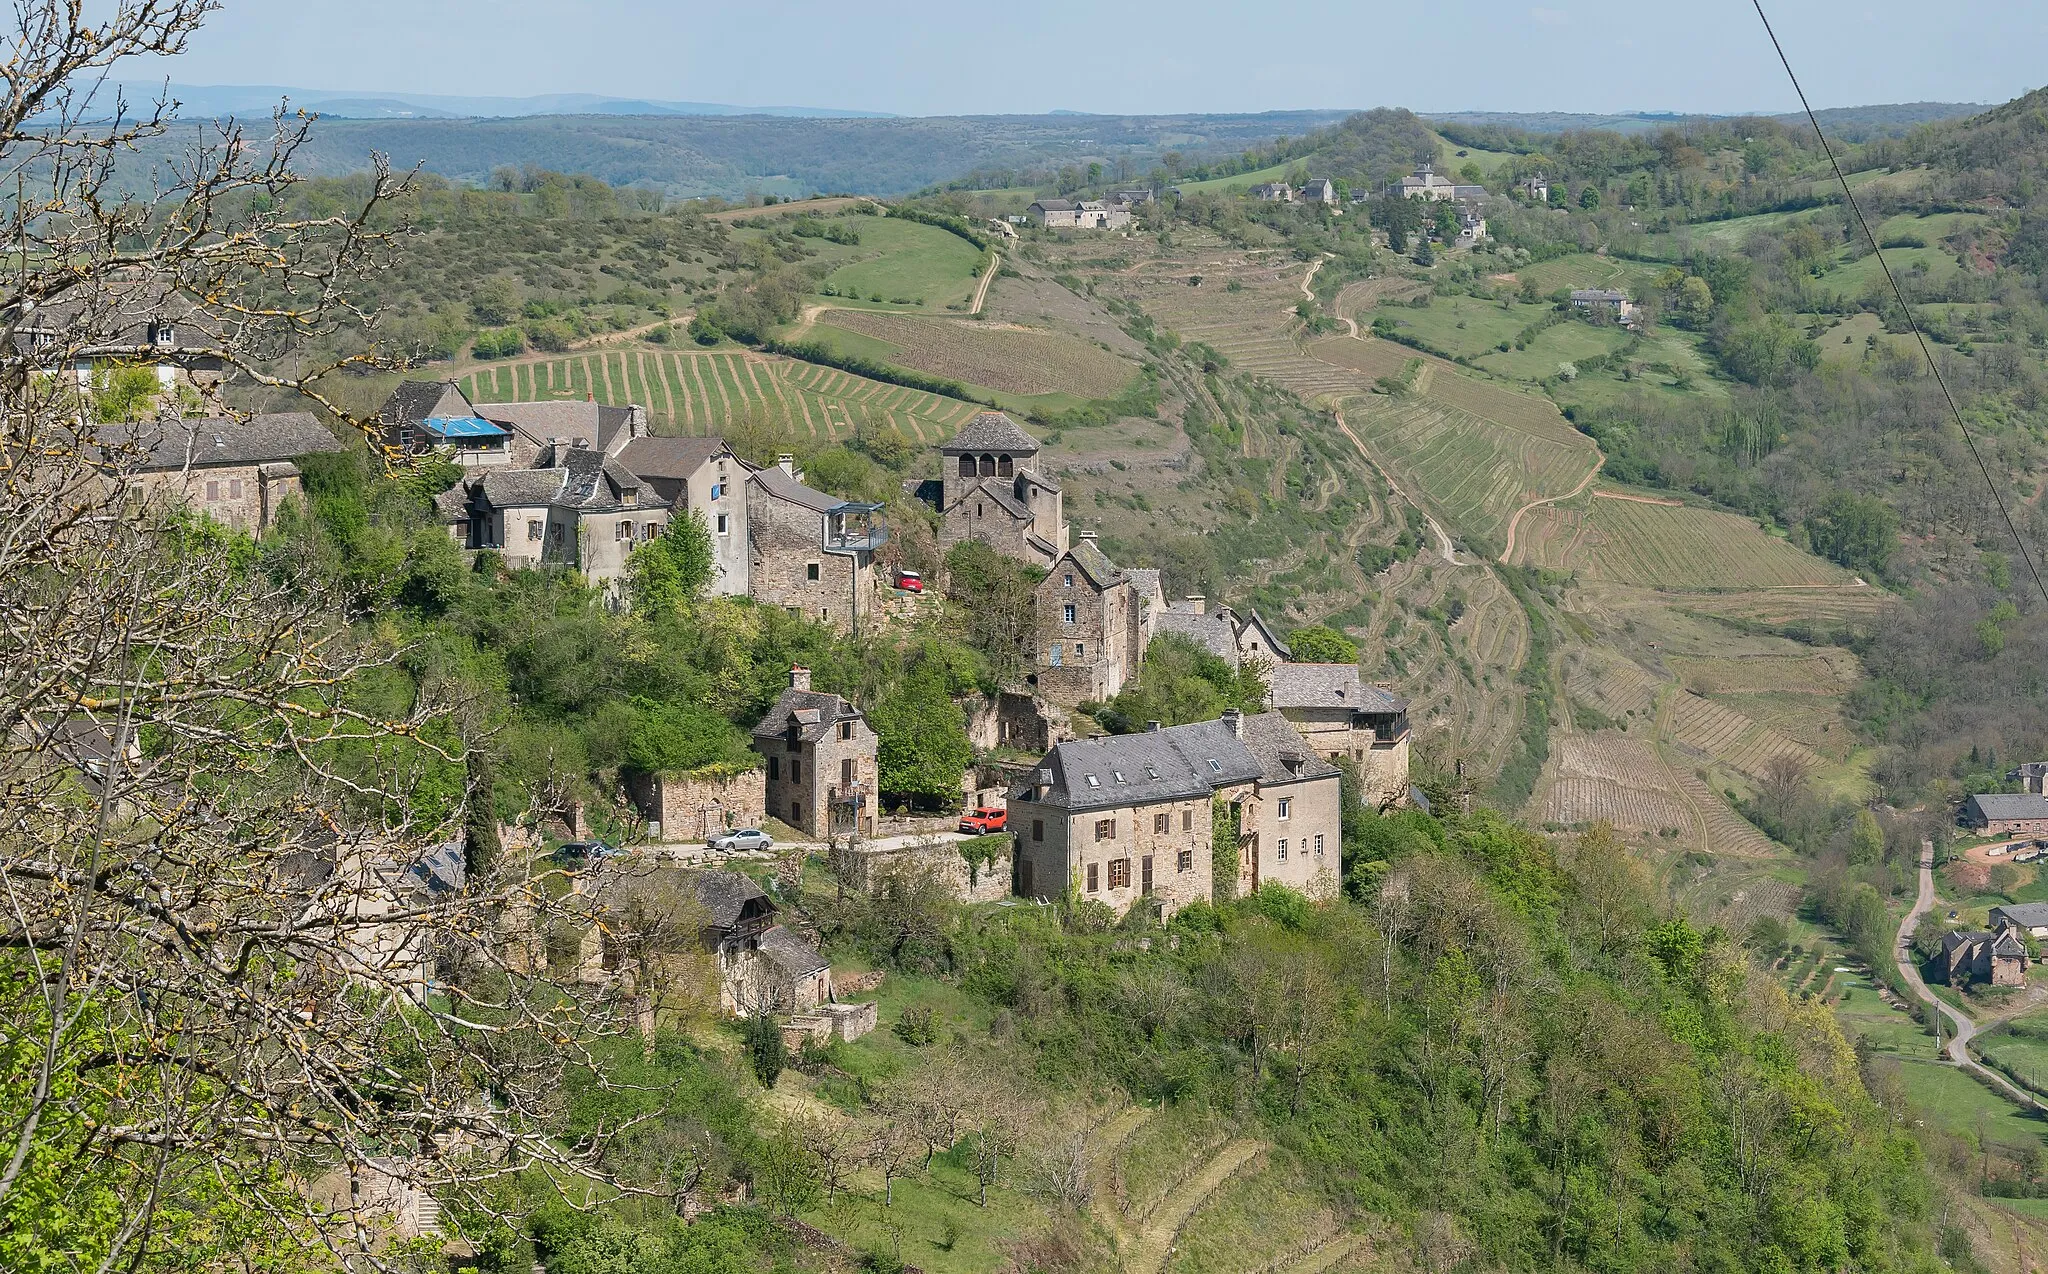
[1038,721,1266,809]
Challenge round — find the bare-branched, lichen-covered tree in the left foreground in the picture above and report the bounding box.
[0,0,638,1270]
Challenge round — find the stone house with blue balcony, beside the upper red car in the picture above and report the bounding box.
[745,457,887,634]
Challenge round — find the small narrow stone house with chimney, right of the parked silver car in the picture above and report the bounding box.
[754,668,881,840]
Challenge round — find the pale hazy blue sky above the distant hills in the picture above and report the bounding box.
[155,0,2048,115]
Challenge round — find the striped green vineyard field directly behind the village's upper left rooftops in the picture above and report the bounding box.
[459,350,981,442]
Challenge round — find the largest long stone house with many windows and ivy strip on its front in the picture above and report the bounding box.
[1010,711,1341,916]
